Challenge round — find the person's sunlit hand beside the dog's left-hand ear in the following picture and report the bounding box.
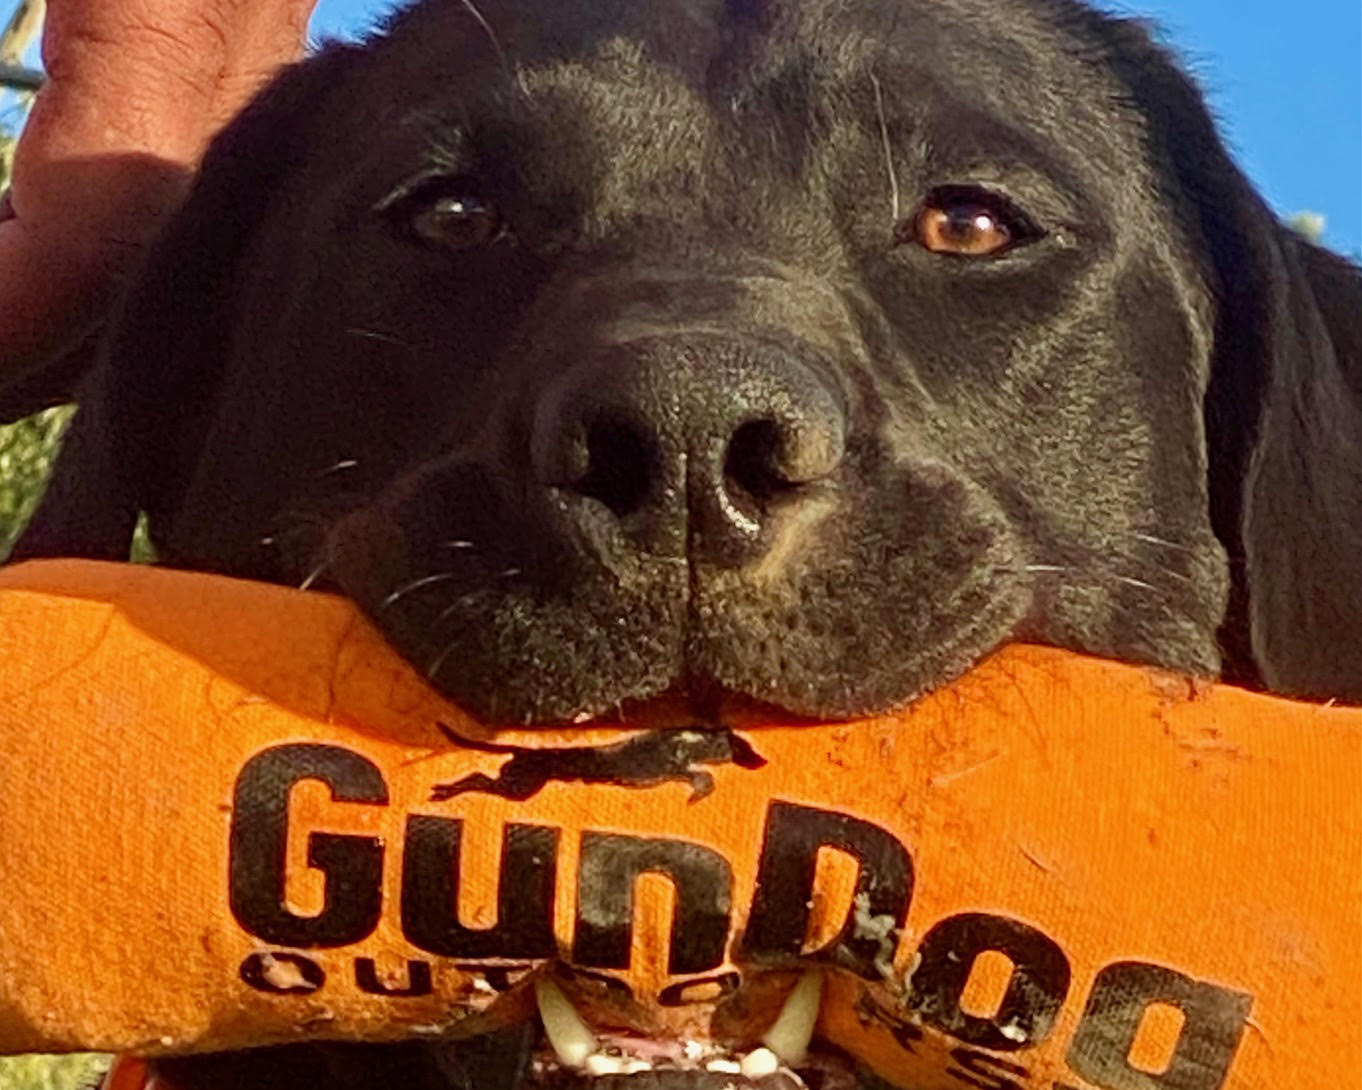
[0,0,316,402]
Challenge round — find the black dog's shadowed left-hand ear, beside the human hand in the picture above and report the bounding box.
[11,45,362,560]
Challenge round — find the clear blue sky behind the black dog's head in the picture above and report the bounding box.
[313,0,1329,255]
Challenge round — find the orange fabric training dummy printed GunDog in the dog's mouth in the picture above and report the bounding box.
[0,561,1362,1090]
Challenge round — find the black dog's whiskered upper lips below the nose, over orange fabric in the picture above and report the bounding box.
[330,463,1031,725]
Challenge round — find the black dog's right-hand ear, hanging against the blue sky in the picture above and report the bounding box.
[1095,21,1362,702]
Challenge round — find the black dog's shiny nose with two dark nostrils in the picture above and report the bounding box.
[531,335,846,567]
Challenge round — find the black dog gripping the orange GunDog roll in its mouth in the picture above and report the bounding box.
[8,0,1362,1085]
